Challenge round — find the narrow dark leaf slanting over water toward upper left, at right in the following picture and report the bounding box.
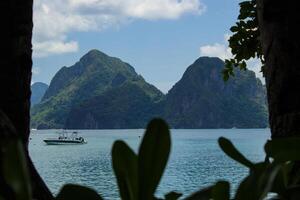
[218,137,253,168]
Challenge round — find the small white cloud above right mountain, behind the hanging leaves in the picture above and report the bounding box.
[200,34,265,83]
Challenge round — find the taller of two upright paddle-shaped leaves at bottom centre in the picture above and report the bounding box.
[138,119,171,200]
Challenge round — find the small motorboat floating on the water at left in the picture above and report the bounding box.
[44,130,87,145]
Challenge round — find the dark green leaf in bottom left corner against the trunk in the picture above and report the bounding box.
[2,140,31,200]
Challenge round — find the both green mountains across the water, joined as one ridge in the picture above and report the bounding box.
[31,50,267,129]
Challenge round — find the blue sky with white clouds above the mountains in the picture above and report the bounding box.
[32,0,262,93]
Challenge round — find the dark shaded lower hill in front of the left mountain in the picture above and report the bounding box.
[65,81,162,129]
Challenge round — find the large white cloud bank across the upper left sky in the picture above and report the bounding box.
[33,0,205,56]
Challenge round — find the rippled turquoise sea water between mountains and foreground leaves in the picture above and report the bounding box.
[29,129,270,199]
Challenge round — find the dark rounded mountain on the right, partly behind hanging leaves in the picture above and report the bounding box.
[164,57,268,128]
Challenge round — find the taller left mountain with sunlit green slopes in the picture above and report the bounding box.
[32,50,164,128]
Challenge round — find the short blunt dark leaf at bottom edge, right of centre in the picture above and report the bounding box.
[212,181,230,200]
